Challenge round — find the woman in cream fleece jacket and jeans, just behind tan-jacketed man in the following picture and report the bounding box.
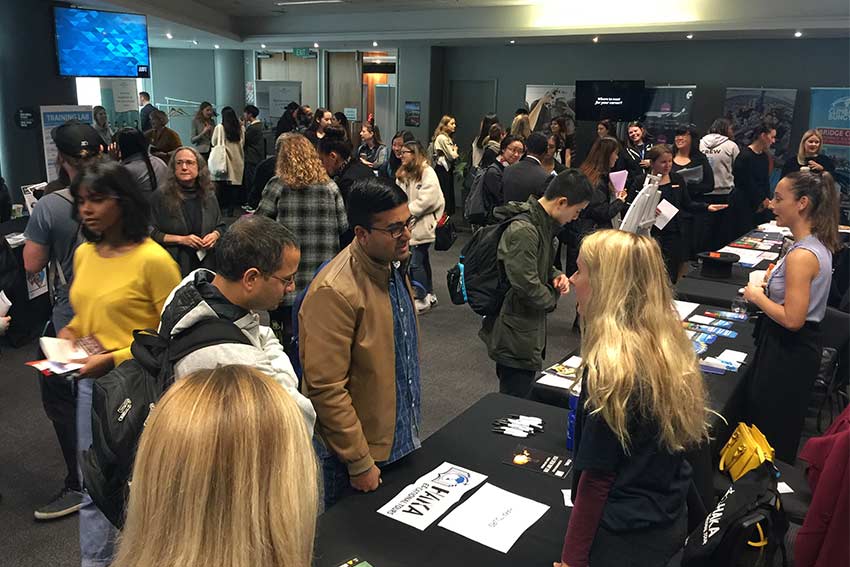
[396,141,446,313]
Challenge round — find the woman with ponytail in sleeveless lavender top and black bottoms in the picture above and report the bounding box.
[744,172,841,463]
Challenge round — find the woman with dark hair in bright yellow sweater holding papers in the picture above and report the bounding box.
[58,162,180,566]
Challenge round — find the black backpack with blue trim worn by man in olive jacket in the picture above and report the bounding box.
[446,213,530,316]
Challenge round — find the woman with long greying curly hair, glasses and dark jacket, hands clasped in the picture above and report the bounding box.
[151,146,224,277]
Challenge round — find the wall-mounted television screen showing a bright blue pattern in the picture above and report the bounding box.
[54,6,150,78]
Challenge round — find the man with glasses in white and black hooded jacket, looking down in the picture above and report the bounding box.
[154,216,316,430]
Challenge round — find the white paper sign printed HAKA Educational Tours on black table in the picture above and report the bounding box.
[378,462,487,530]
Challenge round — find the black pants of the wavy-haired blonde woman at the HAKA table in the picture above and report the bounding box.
[590,510,688,567]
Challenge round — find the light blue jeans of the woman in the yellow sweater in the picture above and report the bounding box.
[77,379,117,567]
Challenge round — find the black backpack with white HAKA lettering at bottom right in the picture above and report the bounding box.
[681,461,788,567]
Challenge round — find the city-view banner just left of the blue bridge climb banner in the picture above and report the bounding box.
[723,88,797,188]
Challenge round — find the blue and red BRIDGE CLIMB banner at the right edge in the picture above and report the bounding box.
[809,87,850,206]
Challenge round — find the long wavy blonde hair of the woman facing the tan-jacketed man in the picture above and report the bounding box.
[579,230,707,451]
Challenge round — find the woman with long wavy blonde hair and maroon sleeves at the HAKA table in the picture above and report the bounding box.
[555,230,707,567]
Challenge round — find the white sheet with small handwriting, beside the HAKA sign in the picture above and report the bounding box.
[437,483,549,553]
